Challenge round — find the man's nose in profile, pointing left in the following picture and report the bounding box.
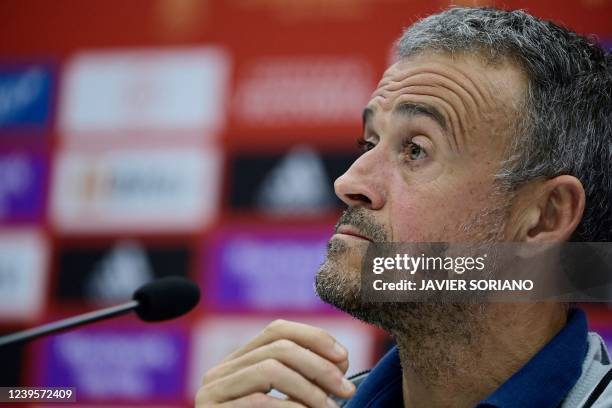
[334,150,385,210]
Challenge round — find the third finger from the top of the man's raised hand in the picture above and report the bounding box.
[198,359,334,408]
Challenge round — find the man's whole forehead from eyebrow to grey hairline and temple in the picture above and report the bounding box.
[364,53,527,151]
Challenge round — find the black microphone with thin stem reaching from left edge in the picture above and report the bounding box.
[0,276,200,347]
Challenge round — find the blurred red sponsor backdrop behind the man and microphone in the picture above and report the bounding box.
[0,0,612,407]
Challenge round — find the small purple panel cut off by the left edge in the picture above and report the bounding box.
[0,152,48,222]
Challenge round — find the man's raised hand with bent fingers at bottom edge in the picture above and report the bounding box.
[196,320,355,408]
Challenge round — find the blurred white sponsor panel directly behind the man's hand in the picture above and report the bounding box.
[189,316,375,395]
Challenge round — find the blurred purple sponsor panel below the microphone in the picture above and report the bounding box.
[37,324,188,402]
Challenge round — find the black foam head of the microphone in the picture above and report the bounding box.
[133,276,200,322]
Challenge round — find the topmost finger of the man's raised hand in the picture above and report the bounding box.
[223,320,348,372]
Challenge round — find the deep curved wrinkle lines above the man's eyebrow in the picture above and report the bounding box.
[372,63,500,150]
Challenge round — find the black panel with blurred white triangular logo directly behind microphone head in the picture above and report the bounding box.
[57,240,191,304]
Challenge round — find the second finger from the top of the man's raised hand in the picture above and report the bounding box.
[205,339,354,398]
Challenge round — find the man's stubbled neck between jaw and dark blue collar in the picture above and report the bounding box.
[393,303,566,408]
